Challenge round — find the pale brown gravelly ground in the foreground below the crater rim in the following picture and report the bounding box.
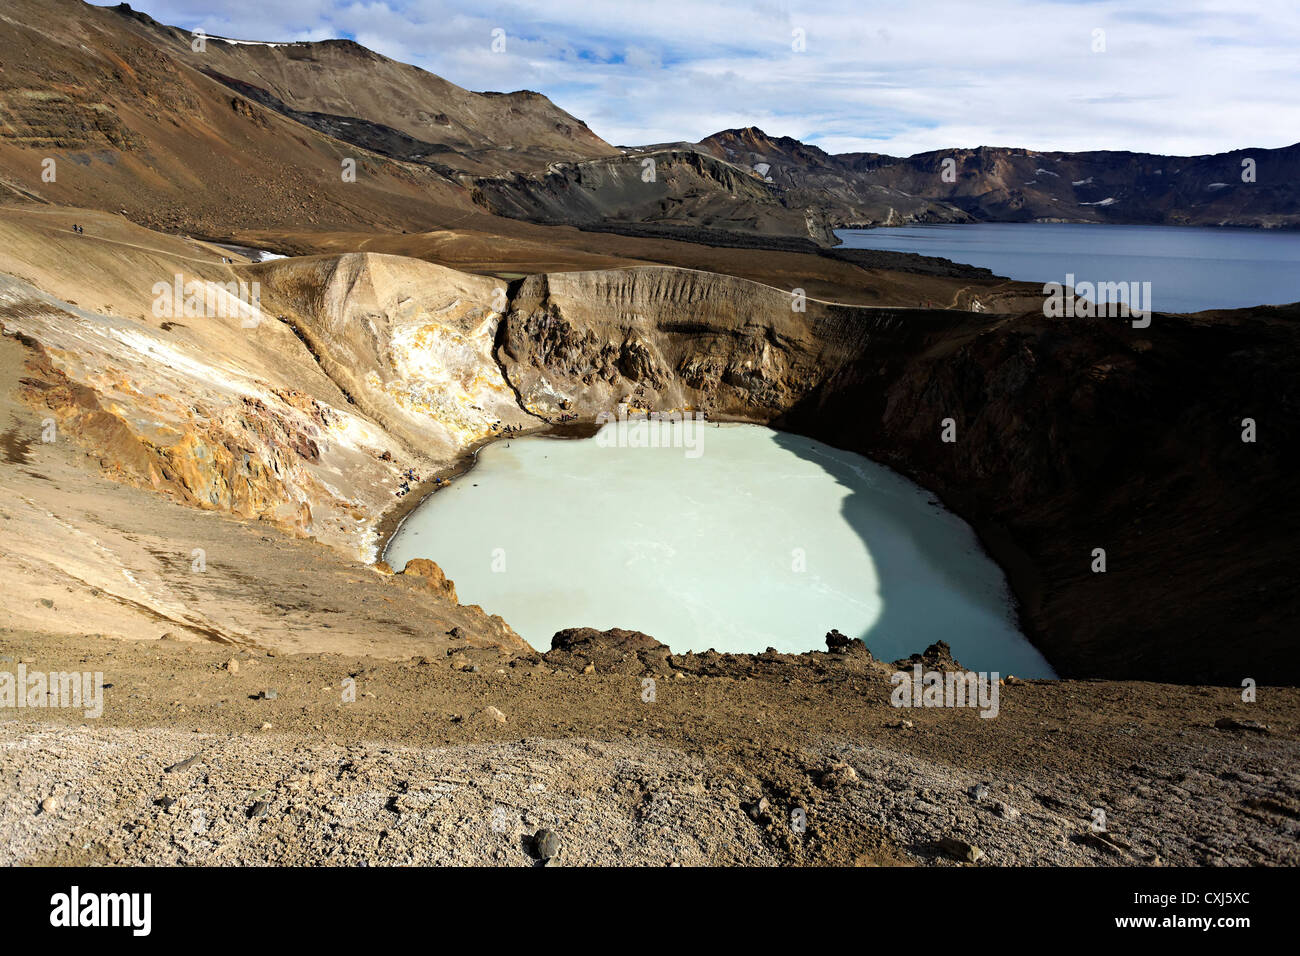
[0,635,1300,866]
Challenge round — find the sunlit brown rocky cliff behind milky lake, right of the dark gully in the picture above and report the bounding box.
[498,267,971,420]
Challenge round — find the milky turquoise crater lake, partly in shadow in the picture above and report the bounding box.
[386,423,1052,676]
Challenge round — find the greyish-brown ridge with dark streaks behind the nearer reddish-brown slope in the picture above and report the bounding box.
[98,4,832,245]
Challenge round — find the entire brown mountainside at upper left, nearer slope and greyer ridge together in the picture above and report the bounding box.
[0,0,833,251]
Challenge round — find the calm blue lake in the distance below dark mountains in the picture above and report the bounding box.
[836,222,1300,312]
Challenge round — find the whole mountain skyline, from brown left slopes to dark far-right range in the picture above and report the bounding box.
[0,0,1300,248]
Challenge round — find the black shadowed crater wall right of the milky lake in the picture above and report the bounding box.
[779,307,1300,685]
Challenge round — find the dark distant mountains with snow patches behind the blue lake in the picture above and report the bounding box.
[699,127,1300,228]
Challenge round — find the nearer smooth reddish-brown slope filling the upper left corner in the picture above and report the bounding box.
[0,0,471,234]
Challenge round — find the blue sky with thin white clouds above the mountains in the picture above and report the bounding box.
[98,0,1300,155]
